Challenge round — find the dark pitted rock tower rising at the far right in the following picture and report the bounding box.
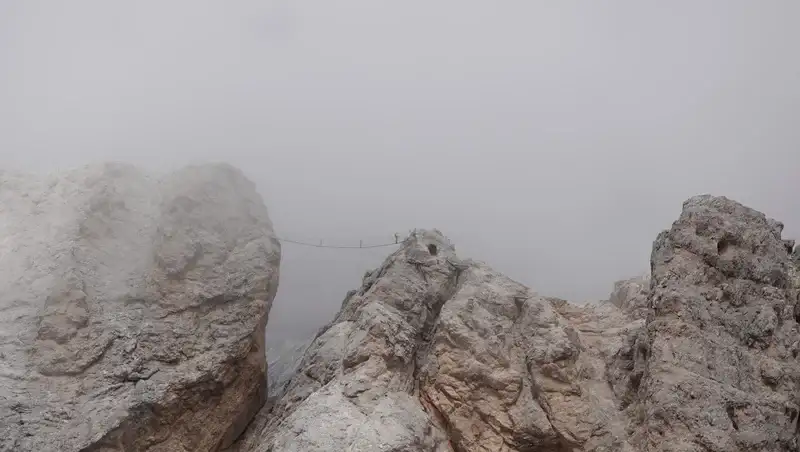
[629,196,800,452]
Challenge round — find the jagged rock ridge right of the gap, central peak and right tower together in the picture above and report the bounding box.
[233,196,800,452]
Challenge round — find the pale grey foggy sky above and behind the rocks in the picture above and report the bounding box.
[0,0,800,337]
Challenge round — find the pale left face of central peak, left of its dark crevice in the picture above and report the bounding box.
[234,233,461,452]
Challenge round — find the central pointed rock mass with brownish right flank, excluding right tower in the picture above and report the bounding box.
[232,231,642,452]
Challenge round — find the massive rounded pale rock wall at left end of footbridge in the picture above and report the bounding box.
[0,164,280,452]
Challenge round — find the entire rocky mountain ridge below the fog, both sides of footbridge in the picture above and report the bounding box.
[0,170,800,452]
